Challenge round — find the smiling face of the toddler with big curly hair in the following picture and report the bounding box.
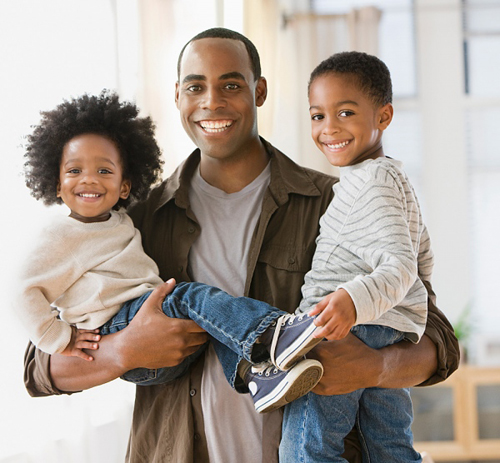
[57,134,130,222]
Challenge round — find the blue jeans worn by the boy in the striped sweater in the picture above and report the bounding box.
[280,325,422,463]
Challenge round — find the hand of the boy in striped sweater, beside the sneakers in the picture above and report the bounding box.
[309,289,356,341]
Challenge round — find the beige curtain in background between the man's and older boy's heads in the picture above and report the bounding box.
[244,0,381,174]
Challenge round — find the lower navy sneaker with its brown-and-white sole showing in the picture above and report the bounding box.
[243,359,323,413]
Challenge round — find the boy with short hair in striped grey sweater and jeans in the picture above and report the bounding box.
[280,52,433,463]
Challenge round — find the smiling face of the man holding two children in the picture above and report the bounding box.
[175,38,267,164]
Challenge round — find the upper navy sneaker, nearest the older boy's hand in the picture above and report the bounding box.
[268,313,323,370]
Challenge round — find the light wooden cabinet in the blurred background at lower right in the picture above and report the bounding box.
[412,365,500,462]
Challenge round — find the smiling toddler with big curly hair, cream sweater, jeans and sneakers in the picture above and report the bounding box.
[16,92,323,412]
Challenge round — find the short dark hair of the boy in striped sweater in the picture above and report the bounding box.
[307,51,392,106]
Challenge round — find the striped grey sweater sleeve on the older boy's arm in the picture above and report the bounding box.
[339,172,419,324]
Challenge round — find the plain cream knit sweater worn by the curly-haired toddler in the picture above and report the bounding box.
[15,211,161,354]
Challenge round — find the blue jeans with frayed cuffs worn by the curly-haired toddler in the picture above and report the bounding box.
[101,283,286,392]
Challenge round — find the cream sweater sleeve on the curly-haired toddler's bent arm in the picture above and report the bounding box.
[14,230,83,354]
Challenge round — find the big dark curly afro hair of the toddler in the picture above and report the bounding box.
[24,90,163,208]
